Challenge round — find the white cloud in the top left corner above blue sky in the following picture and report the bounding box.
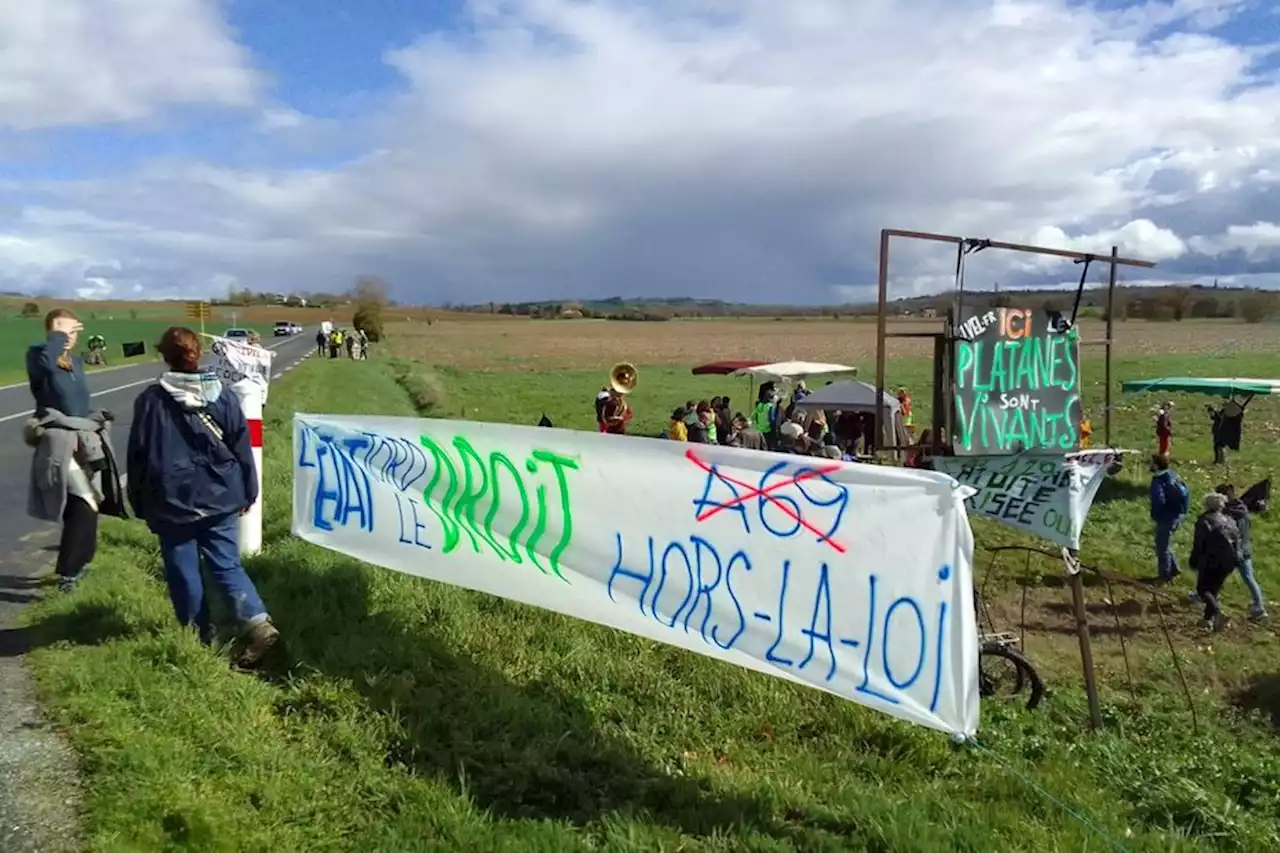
[0,0,259,131]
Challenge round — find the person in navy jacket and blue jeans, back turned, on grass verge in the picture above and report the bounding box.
[128,327,279,666]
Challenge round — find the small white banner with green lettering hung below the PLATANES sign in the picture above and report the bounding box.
[933,450,1124,548]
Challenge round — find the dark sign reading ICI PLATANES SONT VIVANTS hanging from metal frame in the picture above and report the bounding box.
[952,307,1080,456]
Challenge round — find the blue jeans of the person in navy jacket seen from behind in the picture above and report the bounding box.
[156,512,268,643]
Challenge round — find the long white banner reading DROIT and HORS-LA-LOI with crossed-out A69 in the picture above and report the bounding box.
[293,414,978,735]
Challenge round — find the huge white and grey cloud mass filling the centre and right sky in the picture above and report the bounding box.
[0,0,1280,301]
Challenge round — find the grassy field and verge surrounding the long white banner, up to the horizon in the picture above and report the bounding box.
[20,315,1280,853]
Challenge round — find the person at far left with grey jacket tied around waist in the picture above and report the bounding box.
[23,309,123,592]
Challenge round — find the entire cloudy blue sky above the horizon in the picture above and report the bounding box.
[0,0,1280,305]
